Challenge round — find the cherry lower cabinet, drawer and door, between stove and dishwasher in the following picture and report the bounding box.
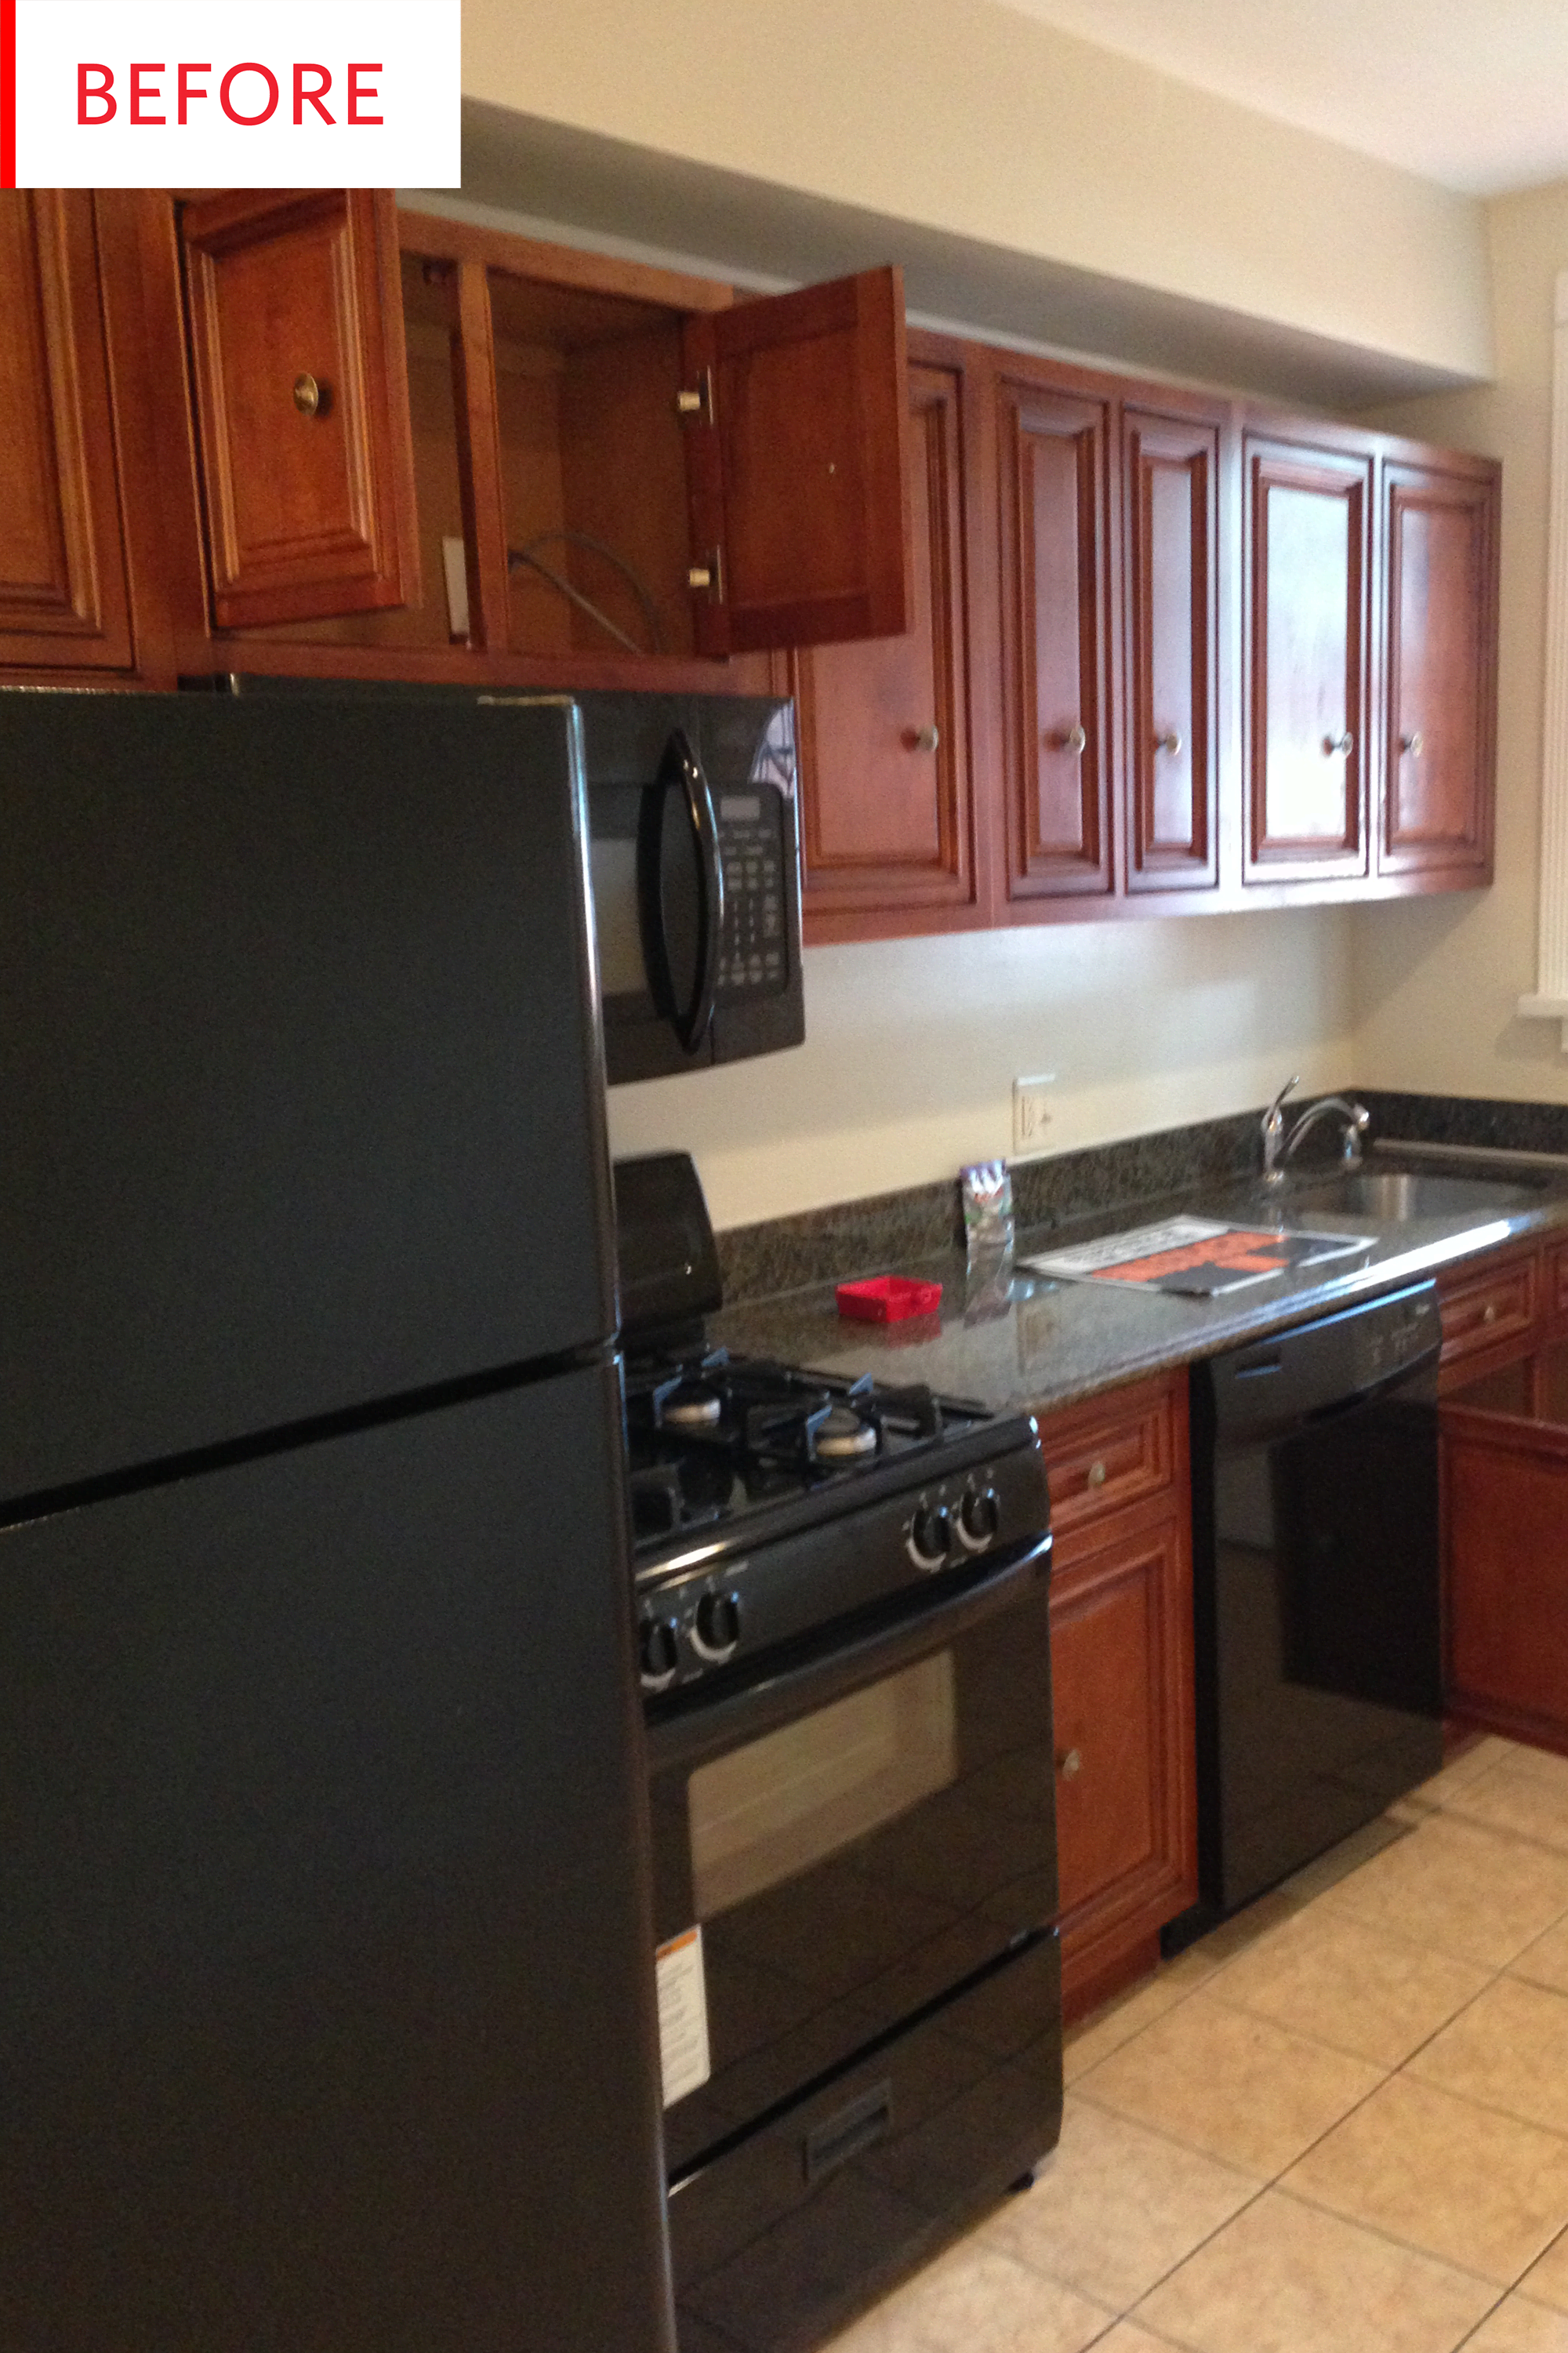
[1040,1372,1199,2017]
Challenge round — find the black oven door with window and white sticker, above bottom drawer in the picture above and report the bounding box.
[650,1539,1057,2181]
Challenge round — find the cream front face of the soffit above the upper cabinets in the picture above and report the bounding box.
[464,0,1490,379]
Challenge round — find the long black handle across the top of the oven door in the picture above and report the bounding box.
[648,1537,1050,1772]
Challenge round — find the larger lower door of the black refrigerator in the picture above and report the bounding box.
[0,1365,671,2353]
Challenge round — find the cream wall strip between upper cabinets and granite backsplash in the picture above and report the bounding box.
[610,908,1352,1226]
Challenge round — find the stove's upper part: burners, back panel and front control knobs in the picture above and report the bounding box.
[617,1155,1045,1701]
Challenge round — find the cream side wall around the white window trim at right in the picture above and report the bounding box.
[1354,181,1568,1103]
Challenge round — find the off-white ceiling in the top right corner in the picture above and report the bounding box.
[1003,0,1568,195]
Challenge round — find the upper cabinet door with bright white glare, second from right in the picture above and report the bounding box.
[1243,435,1373,882]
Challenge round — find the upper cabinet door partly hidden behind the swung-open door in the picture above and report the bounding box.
[793,365,975,939]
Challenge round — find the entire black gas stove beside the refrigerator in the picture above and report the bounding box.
[615,1153,1062,2353]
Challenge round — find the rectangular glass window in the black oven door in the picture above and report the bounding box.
[688,1650,958,1920]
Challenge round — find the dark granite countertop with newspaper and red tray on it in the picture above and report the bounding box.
[709,1153,1568,1412]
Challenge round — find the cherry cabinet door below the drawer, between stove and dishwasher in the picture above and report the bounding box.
[1050,1520,1196,1984]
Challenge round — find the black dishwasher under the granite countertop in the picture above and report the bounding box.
[1165,1283,1443,1951]
